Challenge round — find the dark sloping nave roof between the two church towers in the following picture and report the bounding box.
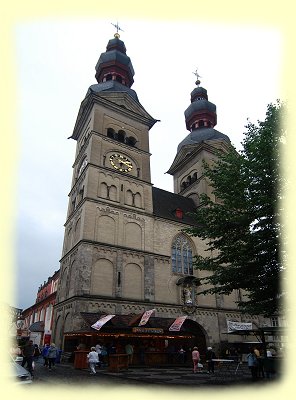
[152,187,196,225]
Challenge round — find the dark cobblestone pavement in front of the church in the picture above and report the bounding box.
[28,361,278,388]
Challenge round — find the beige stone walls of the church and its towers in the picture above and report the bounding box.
[54,33,272,354]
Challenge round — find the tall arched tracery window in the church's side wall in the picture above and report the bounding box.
[172,235,193,275]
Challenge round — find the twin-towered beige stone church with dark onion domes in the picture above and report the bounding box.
[53,33,269,363]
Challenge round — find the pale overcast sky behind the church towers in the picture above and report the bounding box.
[13,18,282,308]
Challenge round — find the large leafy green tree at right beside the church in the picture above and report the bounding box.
[186,102,285,316]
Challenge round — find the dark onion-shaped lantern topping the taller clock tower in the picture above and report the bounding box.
[95,25,135,88]
